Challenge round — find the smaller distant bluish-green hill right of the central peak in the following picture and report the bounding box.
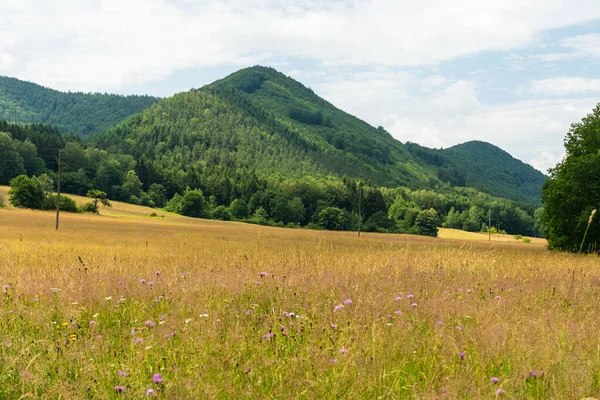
[406,141,548,204]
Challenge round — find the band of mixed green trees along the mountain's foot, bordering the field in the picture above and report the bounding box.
[0,121,543,235]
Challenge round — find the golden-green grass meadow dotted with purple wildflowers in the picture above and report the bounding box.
[0,190,600,399]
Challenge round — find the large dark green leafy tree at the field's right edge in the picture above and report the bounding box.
[542,104,600,251]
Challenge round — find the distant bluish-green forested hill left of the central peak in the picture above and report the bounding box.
[0,76,158,135]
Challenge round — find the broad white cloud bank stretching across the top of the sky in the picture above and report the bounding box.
[0,0,600,90]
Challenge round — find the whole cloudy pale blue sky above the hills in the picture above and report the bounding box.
[0,0,600,172]
